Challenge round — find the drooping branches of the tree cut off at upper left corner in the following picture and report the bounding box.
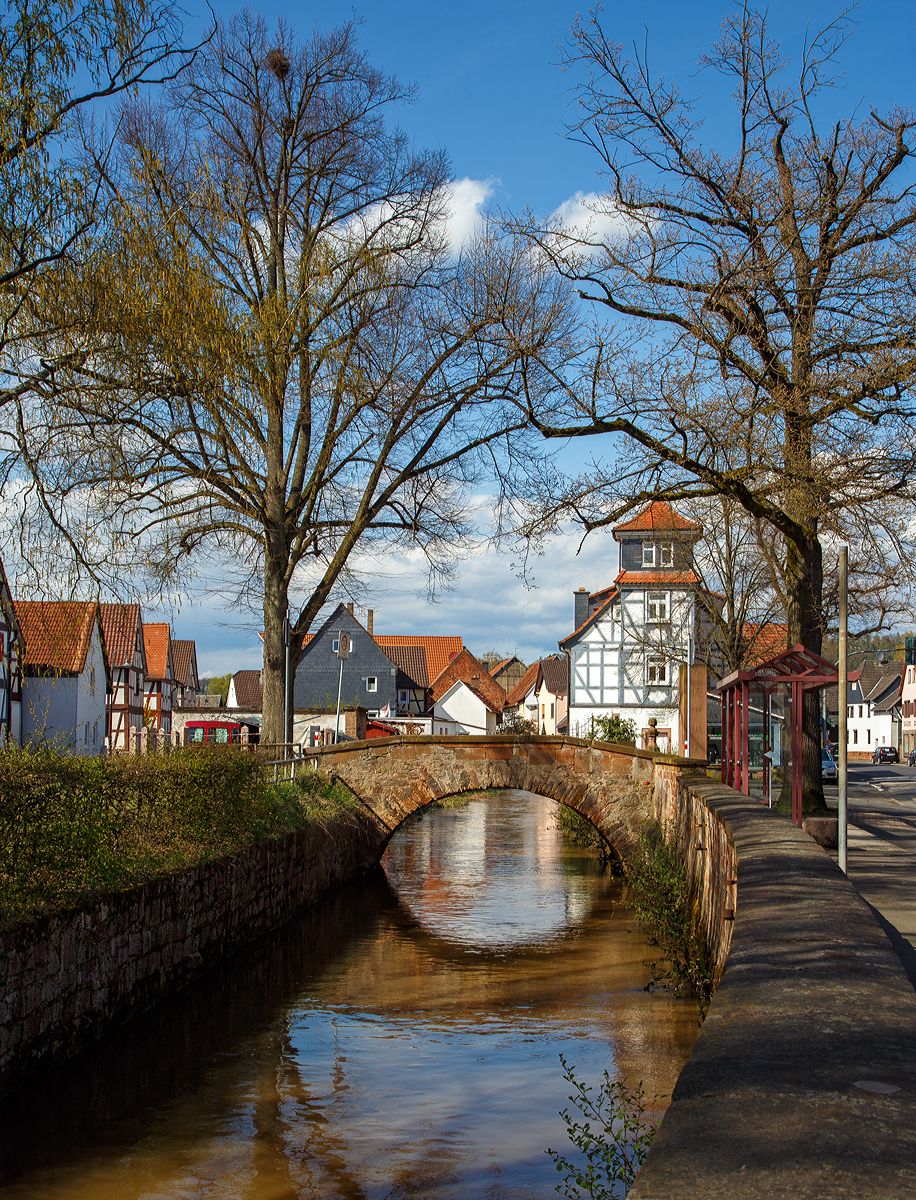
[0,0,199,406]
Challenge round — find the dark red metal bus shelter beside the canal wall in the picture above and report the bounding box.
[718,646,845,826]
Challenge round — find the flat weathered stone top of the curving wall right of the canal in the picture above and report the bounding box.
[629,781,916,1200]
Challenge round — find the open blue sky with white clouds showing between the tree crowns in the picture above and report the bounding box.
[164,0,916,673]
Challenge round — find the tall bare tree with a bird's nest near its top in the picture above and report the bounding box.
[32,13,569,742]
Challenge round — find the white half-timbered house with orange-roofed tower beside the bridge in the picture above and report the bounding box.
[559,502,702,752]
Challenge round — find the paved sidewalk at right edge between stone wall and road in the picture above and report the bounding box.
[833,814,916,988]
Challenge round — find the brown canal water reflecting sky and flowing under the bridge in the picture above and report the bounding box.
[0,791,696,1200]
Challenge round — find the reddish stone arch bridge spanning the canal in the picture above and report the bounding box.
[309,734,684,857]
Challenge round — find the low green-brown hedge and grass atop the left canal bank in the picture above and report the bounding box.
[0,746,355,923]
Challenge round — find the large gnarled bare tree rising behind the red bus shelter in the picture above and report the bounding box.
[527,6,916,803]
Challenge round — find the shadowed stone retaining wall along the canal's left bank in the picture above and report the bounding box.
[0,815,378,1096]
